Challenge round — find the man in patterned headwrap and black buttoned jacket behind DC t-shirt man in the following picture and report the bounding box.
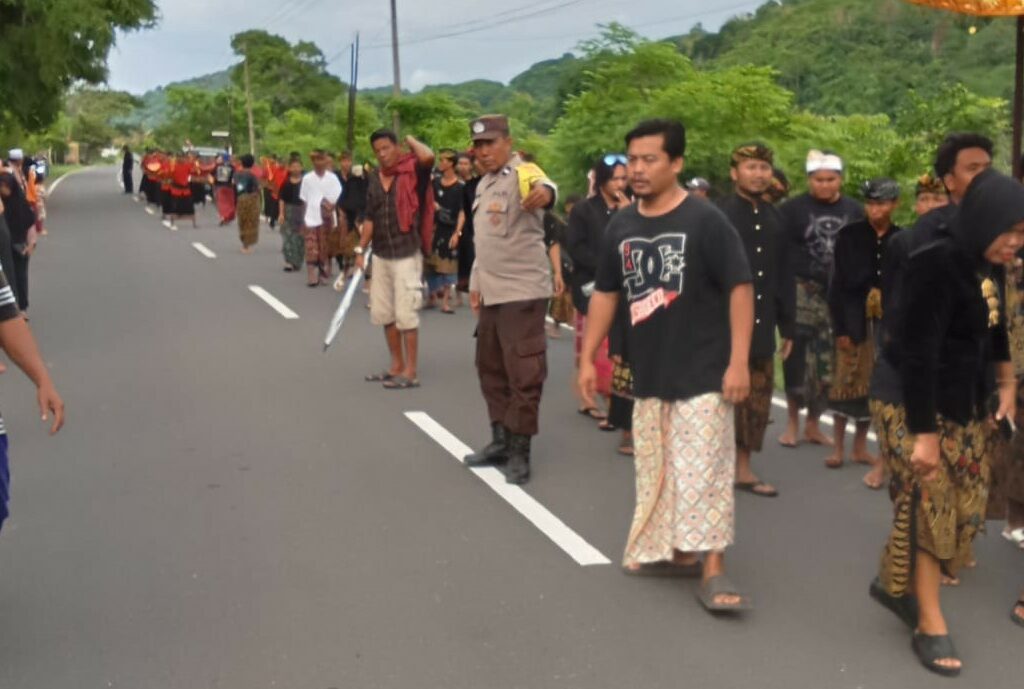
[719,142,797,498]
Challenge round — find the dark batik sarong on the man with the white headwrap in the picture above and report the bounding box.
[783,279,833,416]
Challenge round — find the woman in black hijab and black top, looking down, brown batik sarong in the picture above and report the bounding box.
[870,167,1024,676]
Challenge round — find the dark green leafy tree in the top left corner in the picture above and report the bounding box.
[0,0,157,132]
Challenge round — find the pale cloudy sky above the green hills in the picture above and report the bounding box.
[110,0,767,93]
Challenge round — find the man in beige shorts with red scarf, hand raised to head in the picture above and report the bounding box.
[355,129,434,390]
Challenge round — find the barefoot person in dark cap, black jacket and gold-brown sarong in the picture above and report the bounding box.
[825,177,900,481]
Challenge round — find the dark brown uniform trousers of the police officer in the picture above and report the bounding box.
[476,299,548,435]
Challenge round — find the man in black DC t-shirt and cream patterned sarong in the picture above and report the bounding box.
[580,120,754,612]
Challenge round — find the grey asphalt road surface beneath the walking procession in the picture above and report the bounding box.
[0,169,1024,689]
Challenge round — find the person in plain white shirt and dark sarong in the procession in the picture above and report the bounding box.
[299,148,342,287]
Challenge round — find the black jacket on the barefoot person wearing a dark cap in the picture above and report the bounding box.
[828,220,901,344]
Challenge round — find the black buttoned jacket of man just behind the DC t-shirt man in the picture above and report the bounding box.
[719,193,797,359]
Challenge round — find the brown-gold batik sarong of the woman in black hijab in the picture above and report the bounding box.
[870,399,991,596]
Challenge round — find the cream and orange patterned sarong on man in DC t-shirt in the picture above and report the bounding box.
[624,393,736,567]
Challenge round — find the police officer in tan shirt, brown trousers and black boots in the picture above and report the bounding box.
[465,115,557,484]
